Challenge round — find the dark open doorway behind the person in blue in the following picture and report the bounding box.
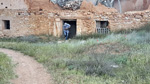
[63,20,76,38]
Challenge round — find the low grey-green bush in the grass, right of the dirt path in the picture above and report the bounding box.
[66,54,115,76]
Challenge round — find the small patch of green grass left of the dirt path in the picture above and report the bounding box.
[0,53,14,84]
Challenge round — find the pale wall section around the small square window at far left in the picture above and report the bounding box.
[0,9,30,36]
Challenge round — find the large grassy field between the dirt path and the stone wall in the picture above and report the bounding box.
[0,31,150,84]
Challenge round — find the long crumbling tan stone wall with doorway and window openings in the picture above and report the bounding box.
[0,2,150,37]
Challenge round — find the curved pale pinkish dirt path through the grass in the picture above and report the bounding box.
[0,49,53,84]
